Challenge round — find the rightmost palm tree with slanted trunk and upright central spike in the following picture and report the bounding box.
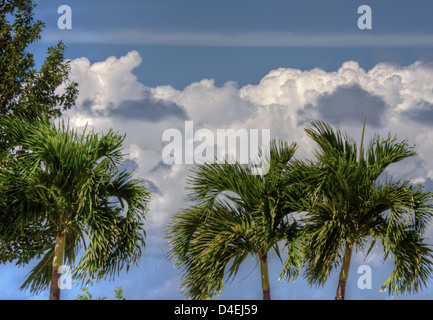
[290,121,433,300]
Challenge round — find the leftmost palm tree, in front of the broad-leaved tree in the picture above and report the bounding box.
[0,119,150,300]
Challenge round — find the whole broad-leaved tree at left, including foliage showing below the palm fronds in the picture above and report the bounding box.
[0,0,78,264]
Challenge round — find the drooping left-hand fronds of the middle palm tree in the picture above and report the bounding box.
[167,204,258,299]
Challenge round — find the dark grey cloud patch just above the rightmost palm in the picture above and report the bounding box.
[300,85,386,127]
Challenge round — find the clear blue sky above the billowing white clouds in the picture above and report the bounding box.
[33,0,433,88]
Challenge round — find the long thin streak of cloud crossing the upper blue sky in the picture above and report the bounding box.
[43,29,433,48]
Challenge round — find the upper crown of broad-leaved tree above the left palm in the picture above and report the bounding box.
[0,0,78,142]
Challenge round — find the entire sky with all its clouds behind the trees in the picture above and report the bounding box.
[0,0,433,300]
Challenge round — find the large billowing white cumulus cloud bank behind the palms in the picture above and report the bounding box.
[53,51,433,299]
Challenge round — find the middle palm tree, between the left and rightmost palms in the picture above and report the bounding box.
[166,142,300,300]
